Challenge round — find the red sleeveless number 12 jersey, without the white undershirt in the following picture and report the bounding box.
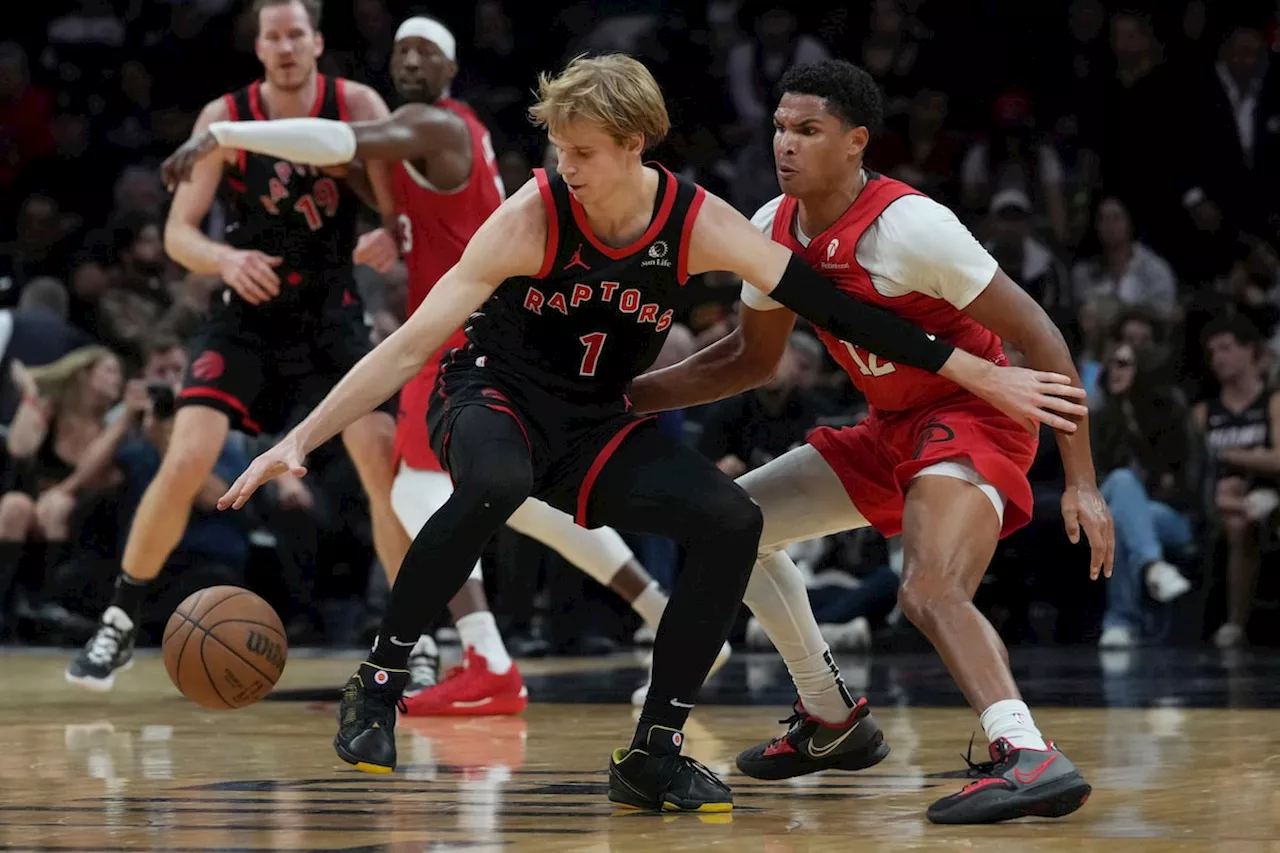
[772,172,1009,411]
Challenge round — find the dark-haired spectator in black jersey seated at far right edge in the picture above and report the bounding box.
[1192,315,1280,648]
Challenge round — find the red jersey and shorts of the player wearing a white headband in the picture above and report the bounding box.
[393,99,506,471]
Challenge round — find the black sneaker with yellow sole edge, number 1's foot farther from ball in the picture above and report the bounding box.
[609,726,733,813]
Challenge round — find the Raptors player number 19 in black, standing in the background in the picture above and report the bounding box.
[67,0,408,690]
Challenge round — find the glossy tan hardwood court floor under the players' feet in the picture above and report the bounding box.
[0,652,1280,853]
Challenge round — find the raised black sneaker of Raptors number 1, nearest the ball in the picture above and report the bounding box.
[333,661,408,774]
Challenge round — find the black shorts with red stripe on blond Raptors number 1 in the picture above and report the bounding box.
[426,351,653,528]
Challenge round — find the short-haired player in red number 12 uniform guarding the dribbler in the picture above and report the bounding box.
[630,60,1115,824]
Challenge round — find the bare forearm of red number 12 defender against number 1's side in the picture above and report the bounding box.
[627,330,777,414]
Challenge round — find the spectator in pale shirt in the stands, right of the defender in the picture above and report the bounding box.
[1071,196,1179,320]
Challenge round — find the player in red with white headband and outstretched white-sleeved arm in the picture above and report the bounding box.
[165,17,730,716]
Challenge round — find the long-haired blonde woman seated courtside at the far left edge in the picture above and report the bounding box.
[0,346,124,617]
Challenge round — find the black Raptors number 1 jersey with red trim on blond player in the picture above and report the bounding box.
[467,165,705,403]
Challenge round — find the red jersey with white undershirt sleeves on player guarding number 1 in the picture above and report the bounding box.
[742,172,1009,411]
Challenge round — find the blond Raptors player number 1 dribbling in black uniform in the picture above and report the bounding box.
[219,56,1090,812]
